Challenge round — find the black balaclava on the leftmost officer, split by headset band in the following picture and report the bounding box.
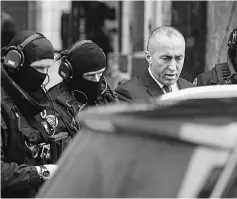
[8,30,54,93]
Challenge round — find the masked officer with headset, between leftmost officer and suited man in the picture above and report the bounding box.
[49,40,117,116]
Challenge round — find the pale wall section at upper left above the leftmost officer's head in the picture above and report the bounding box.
[1,1,71,50]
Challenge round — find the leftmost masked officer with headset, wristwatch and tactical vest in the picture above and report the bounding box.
[1,31,76,198]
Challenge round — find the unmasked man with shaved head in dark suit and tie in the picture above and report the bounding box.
[116,26,194,102]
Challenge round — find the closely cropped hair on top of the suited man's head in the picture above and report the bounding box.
[147,26,185,53]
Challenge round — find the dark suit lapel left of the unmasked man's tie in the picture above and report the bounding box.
[142,69,164,98]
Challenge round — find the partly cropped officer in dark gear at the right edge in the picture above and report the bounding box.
[194,28,237,86]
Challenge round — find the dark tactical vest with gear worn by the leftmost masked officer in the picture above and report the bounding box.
[1,64,78,165]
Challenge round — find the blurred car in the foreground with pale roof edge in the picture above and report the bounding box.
[37,85,237,198]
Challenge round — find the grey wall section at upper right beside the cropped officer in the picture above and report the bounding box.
[205,1,237,70]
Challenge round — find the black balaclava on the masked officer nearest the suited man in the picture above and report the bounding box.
[68,43,106,103]
